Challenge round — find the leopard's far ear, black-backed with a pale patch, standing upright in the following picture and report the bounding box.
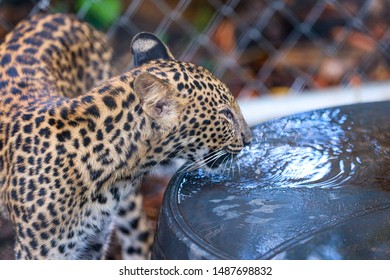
[130,32,174,66]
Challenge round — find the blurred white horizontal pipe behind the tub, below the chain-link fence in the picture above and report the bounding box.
[238,82,390,126]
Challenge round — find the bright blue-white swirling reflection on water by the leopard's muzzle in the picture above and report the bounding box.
[235,110,361,188]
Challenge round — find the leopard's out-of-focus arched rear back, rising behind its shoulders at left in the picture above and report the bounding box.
[0,14,112,111]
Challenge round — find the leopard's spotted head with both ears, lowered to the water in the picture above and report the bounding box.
[131,33,252,169]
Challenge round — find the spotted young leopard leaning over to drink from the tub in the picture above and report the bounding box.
[0,13,252,260]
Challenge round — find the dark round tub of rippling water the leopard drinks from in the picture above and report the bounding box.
[169,102,390,259]
